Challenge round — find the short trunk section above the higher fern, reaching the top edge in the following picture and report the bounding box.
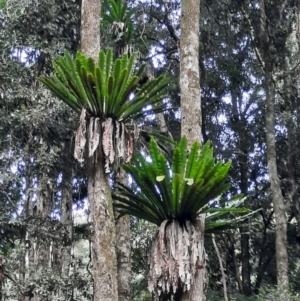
[80,0,101,60]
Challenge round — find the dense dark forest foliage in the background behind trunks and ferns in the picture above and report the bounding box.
[0,0,300,301]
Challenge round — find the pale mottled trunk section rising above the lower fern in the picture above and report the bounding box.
[180,0,201,146]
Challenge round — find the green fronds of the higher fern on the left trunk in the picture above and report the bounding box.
[41,49,168,122]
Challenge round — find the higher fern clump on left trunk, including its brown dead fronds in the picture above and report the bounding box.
[40,49,168,173]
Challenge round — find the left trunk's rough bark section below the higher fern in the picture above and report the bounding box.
[88,147,118,301]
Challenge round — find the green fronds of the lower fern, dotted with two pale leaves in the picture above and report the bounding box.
[113,137,249,227]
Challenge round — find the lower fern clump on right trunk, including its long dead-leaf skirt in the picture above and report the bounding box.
[113,137,249,300]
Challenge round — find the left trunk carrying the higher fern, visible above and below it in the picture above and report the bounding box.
[80,0,118,301]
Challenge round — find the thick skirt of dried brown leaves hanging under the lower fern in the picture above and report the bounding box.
[148,220,204,297]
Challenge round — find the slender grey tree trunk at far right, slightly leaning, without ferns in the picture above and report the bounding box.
[259,0,289,301]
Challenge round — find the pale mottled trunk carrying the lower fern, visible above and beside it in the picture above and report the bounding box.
[180,0,208,301]
